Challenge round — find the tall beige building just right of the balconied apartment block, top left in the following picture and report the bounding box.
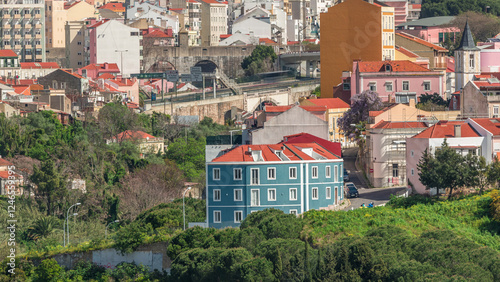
[45,0,96,49]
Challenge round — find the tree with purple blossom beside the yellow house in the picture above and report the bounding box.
[337,90,382,145]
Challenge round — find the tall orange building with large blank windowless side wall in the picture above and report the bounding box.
[320,0,395,98]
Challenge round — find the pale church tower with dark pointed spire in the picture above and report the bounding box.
[455,21,481,91]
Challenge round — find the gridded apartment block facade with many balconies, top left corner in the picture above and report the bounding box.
[0,0,45,62]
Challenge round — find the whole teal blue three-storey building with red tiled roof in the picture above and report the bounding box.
[206,143,344,228]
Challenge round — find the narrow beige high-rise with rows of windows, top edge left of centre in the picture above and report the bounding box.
[201,0,227,46]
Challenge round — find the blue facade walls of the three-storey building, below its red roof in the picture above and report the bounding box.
[207,160,344,228]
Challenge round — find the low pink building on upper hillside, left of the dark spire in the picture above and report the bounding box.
[396,16,460,45]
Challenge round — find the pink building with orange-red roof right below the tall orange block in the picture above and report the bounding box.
[351,61,445,103]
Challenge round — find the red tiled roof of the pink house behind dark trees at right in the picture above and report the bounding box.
[413,121,480,138]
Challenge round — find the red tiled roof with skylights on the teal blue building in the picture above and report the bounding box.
[212,143,339,162]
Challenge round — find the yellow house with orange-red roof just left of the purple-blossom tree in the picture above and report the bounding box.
[300,98,351,142]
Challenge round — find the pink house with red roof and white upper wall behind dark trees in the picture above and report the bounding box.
[406,121,485,195]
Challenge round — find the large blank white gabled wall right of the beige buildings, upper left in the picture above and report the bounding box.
[96,20,142,76]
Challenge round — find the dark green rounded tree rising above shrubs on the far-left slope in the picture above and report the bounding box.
[30,159,68,215]
